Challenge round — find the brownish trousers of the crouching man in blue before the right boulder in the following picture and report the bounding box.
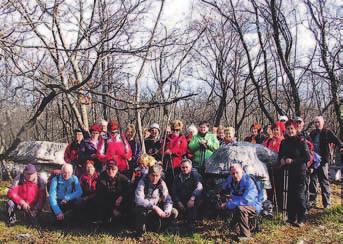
[232,206,256,237]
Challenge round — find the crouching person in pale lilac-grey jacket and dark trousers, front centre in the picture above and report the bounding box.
[134,164,178,234]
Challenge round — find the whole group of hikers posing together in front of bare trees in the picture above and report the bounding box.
[7,116,343,237]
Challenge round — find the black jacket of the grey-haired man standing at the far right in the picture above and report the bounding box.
[310,128,343,164]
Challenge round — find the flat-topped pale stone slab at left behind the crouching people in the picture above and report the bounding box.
[9,141,67,165]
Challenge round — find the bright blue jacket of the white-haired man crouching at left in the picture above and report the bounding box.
[49,175,82,215]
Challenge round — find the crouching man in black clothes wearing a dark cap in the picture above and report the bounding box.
[96,160,131,224]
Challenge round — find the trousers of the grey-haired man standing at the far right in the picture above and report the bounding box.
[309,163,331,207]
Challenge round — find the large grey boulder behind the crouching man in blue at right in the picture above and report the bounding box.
[205,142,277,189]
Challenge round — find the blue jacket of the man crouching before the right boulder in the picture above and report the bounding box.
[222,173,262,213]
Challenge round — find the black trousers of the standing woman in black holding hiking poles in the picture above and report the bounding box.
[287,172,307,222]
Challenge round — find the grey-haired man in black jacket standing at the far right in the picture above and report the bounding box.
[309,116,343,208]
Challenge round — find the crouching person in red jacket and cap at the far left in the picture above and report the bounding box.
[7,164,46,225]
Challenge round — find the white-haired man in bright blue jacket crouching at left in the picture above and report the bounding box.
[49,164,82,221]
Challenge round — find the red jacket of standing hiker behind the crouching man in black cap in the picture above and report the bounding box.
[97,135,132,172]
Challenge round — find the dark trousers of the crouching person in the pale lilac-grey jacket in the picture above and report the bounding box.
[134,206,178,232]
